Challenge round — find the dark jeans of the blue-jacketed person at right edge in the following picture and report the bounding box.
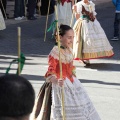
[114,13,120,37]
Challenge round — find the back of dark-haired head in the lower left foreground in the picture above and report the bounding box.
[0,75,35,120]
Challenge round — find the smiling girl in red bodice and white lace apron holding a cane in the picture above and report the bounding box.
[32,25,101,120]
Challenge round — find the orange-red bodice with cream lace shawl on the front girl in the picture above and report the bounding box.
[45,46,75,82]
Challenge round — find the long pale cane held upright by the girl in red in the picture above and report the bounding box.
[54,5,66,120]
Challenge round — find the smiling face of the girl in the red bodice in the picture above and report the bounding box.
[60,29,74,47]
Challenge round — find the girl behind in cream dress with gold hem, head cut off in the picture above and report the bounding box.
[73,0,114,64]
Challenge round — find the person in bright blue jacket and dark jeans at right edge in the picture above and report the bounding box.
[111,0,120,41]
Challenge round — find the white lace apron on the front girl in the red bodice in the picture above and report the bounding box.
[51,78,100,120]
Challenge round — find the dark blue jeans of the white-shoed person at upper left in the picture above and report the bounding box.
[14,0,25,18]
